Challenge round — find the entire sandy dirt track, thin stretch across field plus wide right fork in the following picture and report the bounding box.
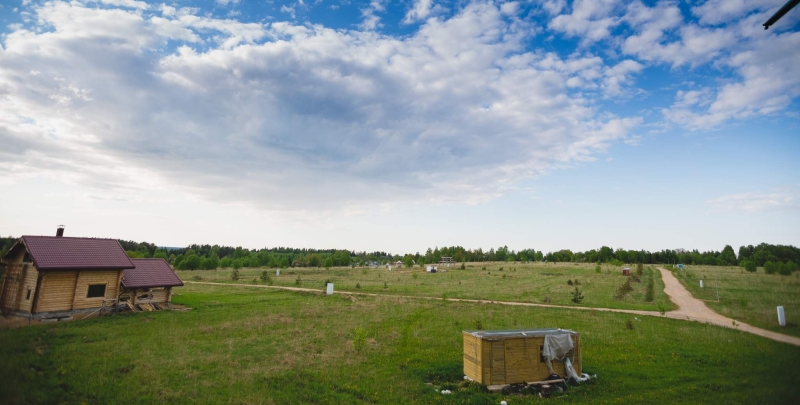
[184,276,800,346]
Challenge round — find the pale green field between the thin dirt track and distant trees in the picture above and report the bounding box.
[178,263,675,311]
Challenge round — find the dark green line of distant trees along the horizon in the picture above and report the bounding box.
[0,237,800,274]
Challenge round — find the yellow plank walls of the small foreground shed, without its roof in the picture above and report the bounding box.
[464,333,582,385]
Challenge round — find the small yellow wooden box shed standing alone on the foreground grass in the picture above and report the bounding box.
[463,329,582,385]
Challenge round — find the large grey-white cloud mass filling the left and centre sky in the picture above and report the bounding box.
[0,2,641,210]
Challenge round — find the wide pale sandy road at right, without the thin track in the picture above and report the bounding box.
[658,267,800,346]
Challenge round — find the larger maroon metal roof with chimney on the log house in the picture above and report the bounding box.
[22,236,133,270]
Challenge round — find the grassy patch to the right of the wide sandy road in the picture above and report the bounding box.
[666,266,800,336]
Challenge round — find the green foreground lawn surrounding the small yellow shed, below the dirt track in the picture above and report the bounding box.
[0,282,800,405]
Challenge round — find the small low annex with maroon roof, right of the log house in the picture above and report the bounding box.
[119,259,183,306]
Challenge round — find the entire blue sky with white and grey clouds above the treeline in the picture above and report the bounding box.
[0,0,800,254]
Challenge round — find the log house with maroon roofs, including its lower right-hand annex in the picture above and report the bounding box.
[0,227,183,316]
